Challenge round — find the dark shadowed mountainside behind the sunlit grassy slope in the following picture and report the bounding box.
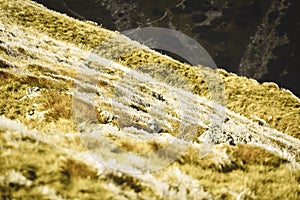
[36,0,300,97]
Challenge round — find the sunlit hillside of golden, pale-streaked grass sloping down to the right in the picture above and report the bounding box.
[0,0,300,199]
